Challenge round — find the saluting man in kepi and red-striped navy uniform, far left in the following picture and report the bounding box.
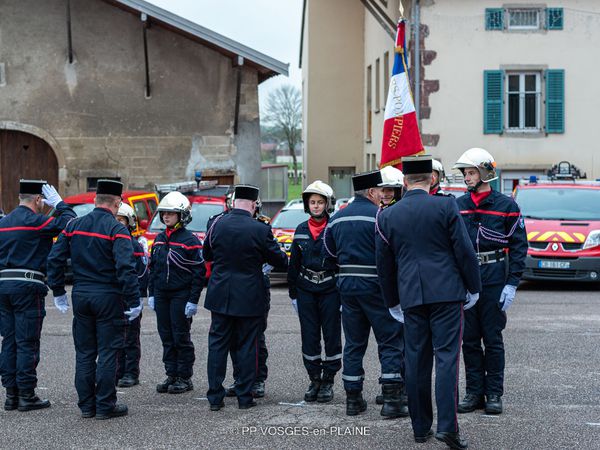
[0,180,76,411]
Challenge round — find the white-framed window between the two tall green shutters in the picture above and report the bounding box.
[506,72,542,131]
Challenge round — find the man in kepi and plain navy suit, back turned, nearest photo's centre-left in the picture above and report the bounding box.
[203,185,287,411]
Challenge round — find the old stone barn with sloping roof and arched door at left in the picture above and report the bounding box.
[0,0,288,210]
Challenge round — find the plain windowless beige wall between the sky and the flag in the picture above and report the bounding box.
[302,0,364,194]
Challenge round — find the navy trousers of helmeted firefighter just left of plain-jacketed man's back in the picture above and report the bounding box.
[154,290,195,378]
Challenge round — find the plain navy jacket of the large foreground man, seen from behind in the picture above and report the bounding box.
[377,189,481,310]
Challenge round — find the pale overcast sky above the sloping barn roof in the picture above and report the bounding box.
[146,0,302,112]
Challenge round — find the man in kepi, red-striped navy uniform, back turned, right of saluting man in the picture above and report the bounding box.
[48,180,142,420]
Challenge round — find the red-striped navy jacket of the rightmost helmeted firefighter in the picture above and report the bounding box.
[456,190,527,286]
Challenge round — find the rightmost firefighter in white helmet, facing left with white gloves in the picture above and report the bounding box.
[454,148,527,414]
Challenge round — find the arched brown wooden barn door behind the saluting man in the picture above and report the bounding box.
[0,130,58,213]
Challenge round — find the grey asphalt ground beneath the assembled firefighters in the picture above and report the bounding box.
[0,283,600,449]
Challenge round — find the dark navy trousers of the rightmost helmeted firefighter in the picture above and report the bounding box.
[463,284,506,395]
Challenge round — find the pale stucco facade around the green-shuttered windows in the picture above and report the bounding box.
[421,0,600,178]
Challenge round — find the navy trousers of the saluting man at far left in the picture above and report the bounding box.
[0,293,46,390]
